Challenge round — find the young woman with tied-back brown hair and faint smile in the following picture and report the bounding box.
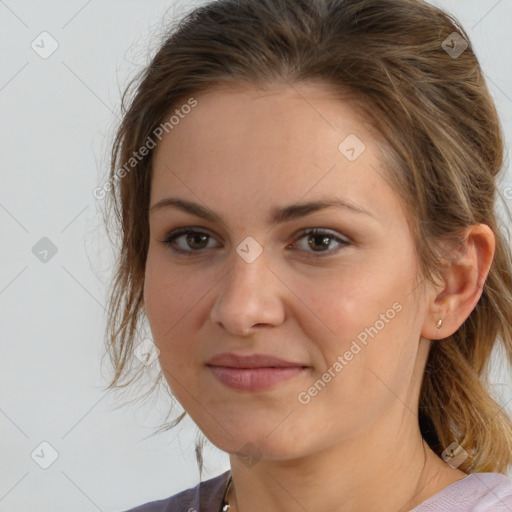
[103,0,512,512]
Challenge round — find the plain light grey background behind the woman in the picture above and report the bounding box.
[0,0,512,512]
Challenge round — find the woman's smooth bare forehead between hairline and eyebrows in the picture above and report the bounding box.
[151,83,396,224]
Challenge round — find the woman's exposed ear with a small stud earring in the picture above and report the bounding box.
[421,224,496,340]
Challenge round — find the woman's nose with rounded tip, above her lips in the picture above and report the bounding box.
[210,248,286,336]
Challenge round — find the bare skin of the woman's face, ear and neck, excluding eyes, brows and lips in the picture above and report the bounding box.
[144,83,494,512]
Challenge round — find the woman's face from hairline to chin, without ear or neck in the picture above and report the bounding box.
[144,83,428,459]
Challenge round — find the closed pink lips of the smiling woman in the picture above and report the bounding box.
[207,353,306,391]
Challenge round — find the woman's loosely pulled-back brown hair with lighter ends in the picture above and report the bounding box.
[102,0,512,473]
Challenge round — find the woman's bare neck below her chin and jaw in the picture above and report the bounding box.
[228,412,466,512]
